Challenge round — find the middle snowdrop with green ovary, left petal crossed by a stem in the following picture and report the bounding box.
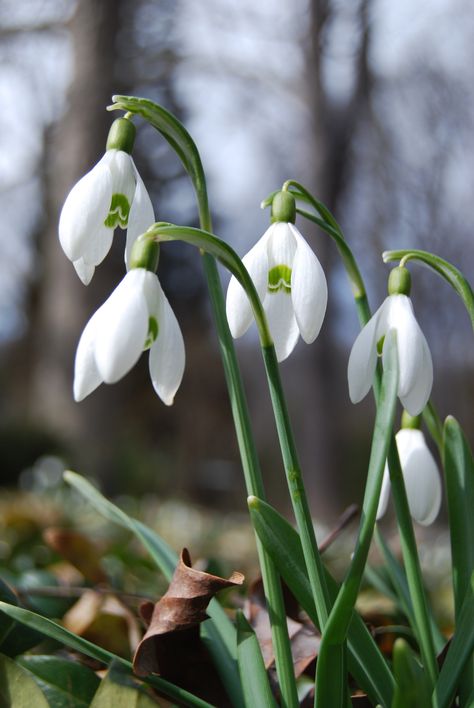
[226,192,327,361]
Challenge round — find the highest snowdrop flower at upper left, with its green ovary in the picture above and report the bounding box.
[59,118,155,285]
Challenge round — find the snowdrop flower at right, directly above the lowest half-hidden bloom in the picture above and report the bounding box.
[348,268,433,415]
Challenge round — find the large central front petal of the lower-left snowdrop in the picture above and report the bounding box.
[95,268,149,383]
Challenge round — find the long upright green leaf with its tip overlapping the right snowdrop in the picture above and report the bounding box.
[315,332,398,708]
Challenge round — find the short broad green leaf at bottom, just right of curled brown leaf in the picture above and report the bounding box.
[236,611,276,708]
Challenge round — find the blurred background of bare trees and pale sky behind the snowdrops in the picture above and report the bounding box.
[0,0,474,524]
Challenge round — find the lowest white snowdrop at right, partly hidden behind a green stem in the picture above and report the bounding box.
[377,428,441,526]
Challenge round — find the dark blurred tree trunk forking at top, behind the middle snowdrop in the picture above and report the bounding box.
[301,0,371,516]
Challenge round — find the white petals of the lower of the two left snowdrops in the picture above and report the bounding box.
[74,268,185,406]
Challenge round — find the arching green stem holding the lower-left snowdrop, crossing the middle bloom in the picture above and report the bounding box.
[140,223,330,626]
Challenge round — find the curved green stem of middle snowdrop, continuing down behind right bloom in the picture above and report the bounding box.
[294,187,438,685]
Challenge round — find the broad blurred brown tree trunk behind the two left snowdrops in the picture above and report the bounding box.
[25,0,128,476]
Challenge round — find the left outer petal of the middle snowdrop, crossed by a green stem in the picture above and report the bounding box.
[226,224,274,337]
